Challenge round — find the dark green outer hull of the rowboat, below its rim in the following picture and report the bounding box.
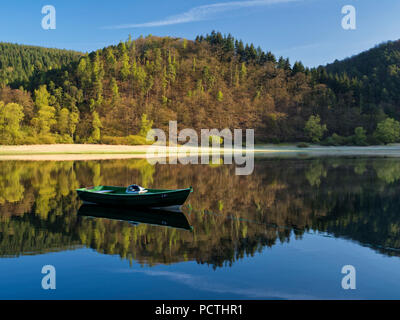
[77,188,192,208]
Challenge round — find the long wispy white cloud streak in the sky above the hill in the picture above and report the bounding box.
[103,0,299,29]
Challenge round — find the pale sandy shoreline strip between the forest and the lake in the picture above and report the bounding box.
[0,144,400,161]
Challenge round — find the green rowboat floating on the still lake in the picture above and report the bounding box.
[76,186,193,208]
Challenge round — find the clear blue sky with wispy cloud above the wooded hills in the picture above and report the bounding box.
[0,0,400,66]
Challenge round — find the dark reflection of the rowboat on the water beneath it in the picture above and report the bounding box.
[78,203,193,231]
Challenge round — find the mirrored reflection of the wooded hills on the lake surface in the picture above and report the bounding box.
[0,159,400,267]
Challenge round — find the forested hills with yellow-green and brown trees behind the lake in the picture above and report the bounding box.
[0,31,400,145]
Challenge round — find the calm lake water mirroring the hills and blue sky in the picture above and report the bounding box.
[0,157,400,299]
